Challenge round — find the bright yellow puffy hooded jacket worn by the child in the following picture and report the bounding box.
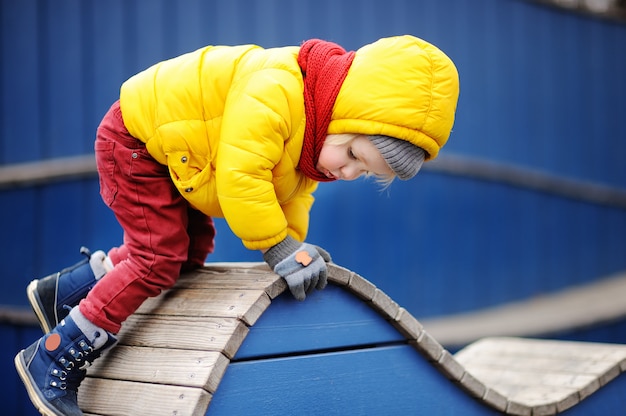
[120,36,458,249]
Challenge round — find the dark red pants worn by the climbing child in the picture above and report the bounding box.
[79,102,215,333]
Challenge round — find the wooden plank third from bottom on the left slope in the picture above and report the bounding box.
[119,314,249,358]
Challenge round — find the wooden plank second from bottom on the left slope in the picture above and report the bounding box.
[88,345,229,393]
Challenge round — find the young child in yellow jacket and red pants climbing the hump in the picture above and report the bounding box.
[15,35,459,415]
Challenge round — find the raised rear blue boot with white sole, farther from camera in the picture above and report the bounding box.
[26,247,106,333]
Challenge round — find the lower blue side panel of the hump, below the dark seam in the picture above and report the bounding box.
[212,345,499,416]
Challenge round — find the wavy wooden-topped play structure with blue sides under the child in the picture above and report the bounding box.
[79,263,626,416]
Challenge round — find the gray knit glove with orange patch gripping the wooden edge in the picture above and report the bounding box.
[263,236,331,300]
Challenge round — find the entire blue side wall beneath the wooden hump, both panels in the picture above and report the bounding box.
[207,285,497,416]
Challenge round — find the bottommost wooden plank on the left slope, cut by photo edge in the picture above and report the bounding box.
[78,377,212,416]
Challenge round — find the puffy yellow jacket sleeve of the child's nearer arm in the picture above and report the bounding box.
[215,69,310,249]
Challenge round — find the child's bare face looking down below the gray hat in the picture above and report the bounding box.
[315,135,392,181]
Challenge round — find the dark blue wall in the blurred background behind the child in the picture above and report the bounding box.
[0,0,626,414]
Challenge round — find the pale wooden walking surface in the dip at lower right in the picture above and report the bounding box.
[455,338,626,415]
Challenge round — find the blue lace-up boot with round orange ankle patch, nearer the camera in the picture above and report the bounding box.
[15,308,117,416]
